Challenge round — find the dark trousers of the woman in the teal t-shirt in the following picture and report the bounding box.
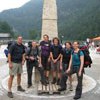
[60,67,83,96]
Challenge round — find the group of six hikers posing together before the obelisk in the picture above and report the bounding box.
[8,34,84,99]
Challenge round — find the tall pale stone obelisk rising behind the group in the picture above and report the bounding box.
[41,0,58,39]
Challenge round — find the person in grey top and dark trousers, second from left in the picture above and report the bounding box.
[26,41,47,88]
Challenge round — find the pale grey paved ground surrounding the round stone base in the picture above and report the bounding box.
[0,45,100,100]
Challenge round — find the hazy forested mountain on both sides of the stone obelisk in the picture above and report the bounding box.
[0,0,100,40]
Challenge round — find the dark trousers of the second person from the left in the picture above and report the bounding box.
[26,61,45,85]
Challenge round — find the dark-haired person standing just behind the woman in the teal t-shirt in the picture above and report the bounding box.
[60,42,73,91]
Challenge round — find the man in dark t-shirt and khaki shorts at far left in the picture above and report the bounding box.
[8,36,25,98]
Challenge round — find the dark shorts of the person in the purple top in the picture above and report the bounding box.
[41,56,51,71]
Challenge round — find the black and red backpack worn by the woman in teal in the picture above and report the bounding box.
[78,46,92,68]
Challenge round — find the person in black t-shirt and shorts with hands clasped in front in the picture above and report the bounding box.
[50,37,62,85]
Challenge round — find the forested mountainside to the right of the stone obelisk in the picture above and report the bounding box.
[57,0,100,40]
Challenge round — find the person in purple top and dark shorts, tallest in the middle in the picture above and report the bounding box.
[40,34,51,84]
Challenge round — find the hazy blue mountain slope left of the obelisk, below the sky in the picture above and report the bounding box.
[0,0,42,38]
